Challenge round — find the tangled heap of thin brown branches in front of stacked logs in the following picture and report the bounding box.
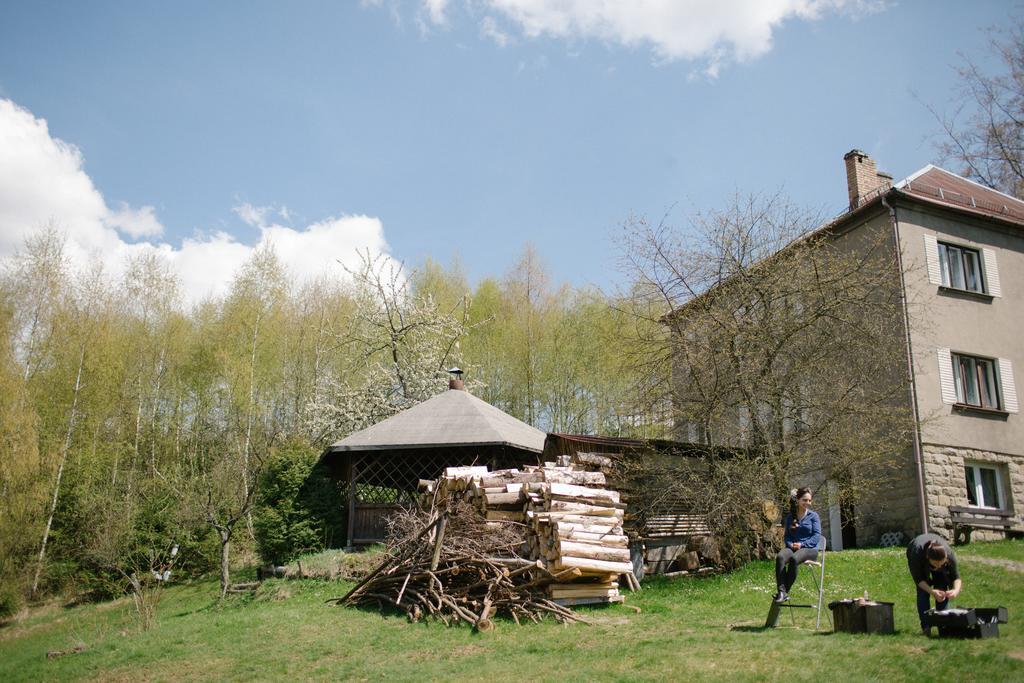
[329,500,585,631]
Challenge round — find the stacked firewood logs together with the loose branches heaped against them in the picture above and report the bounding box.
[334,464,639,631]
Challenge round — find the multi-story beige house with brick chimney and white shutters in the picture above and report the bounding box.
[677,150,1024,548]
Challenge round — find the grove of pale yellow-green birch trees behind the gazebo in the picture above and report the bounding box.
[0,233,638,614]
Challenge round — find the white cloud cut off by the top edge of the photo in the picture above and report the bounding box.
[407,0,885,77]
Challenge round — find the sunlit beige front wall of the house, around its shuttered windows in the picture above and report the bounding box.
[897,200,1024,538]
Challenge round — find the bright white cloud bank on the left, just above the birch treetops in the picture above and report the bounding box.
[0,99,388,303]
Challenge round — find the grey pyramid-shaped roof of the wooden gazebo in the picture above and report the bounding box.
[328,389,546,453]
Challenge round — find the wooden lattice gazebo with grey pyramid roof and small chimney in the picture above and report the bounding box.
[321,380,546,547]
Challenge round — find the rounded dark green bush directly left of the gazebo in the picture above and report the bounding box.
[253,441,344,564]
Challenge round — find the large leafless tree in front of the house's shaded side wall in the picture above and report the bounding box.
[625,196,911,520]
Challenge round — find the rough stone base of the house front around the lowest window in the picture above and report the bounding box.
[923,443,1024,540]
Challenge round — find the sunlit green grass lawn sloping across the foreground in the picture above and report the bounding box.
[0,542,1024,682]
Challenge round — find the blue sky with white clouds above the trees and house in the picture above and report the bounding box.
[0,0,1020,298]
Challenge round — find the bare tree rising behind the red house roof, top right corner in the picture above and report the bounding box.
[929,17,1024,198]
